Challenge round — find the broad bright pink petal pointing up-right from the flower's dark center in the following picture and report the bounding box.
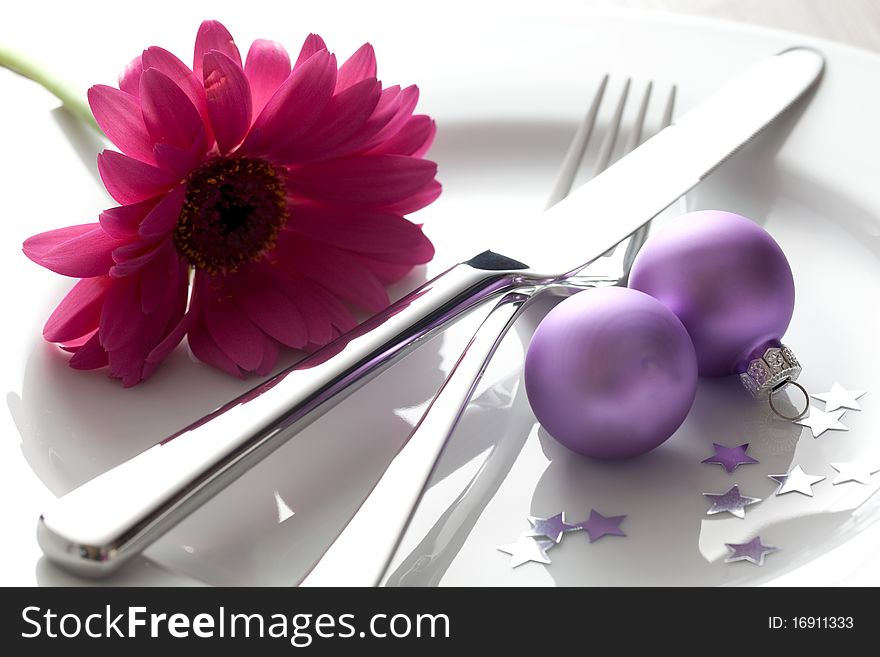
[239,50,336,154]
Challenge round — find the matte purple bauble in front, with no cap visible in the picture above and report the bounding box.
[525,287,697,459]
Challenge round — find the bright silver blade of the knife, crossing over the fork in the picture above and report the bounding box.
[492,48,823,273]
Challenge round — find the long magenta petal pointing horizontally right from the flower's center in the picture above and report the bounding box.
[287,155,437,208]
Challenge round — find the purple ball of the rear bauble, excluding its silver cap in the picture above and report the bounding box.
[629,210,794,376]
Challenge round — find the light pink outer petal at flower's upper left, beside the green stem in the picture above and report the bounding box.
[88,84,153,164]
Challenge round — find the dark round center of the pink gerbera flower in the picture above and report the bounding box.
[173,157,287,274]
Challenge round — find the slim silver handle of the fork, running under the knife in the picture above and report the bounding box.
[300,288,535,586]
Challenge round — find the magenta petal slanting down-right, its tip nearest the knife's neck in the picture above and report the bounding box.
[277,235,388,312]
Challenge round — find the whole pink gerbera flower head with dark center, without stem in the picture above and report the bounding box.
[24,21,440,386]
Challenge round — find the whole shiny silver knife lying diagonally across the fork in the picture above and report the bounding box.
[37,48,823,576]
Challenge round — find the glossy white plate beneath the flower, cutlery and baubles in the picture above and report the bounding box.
[0,3,880,585]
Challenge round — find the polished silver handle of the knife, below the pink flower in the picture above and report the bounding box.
[37,252,524,577]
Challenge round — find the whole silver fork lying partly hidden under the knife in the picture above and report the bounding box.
[300,75,675,586]
